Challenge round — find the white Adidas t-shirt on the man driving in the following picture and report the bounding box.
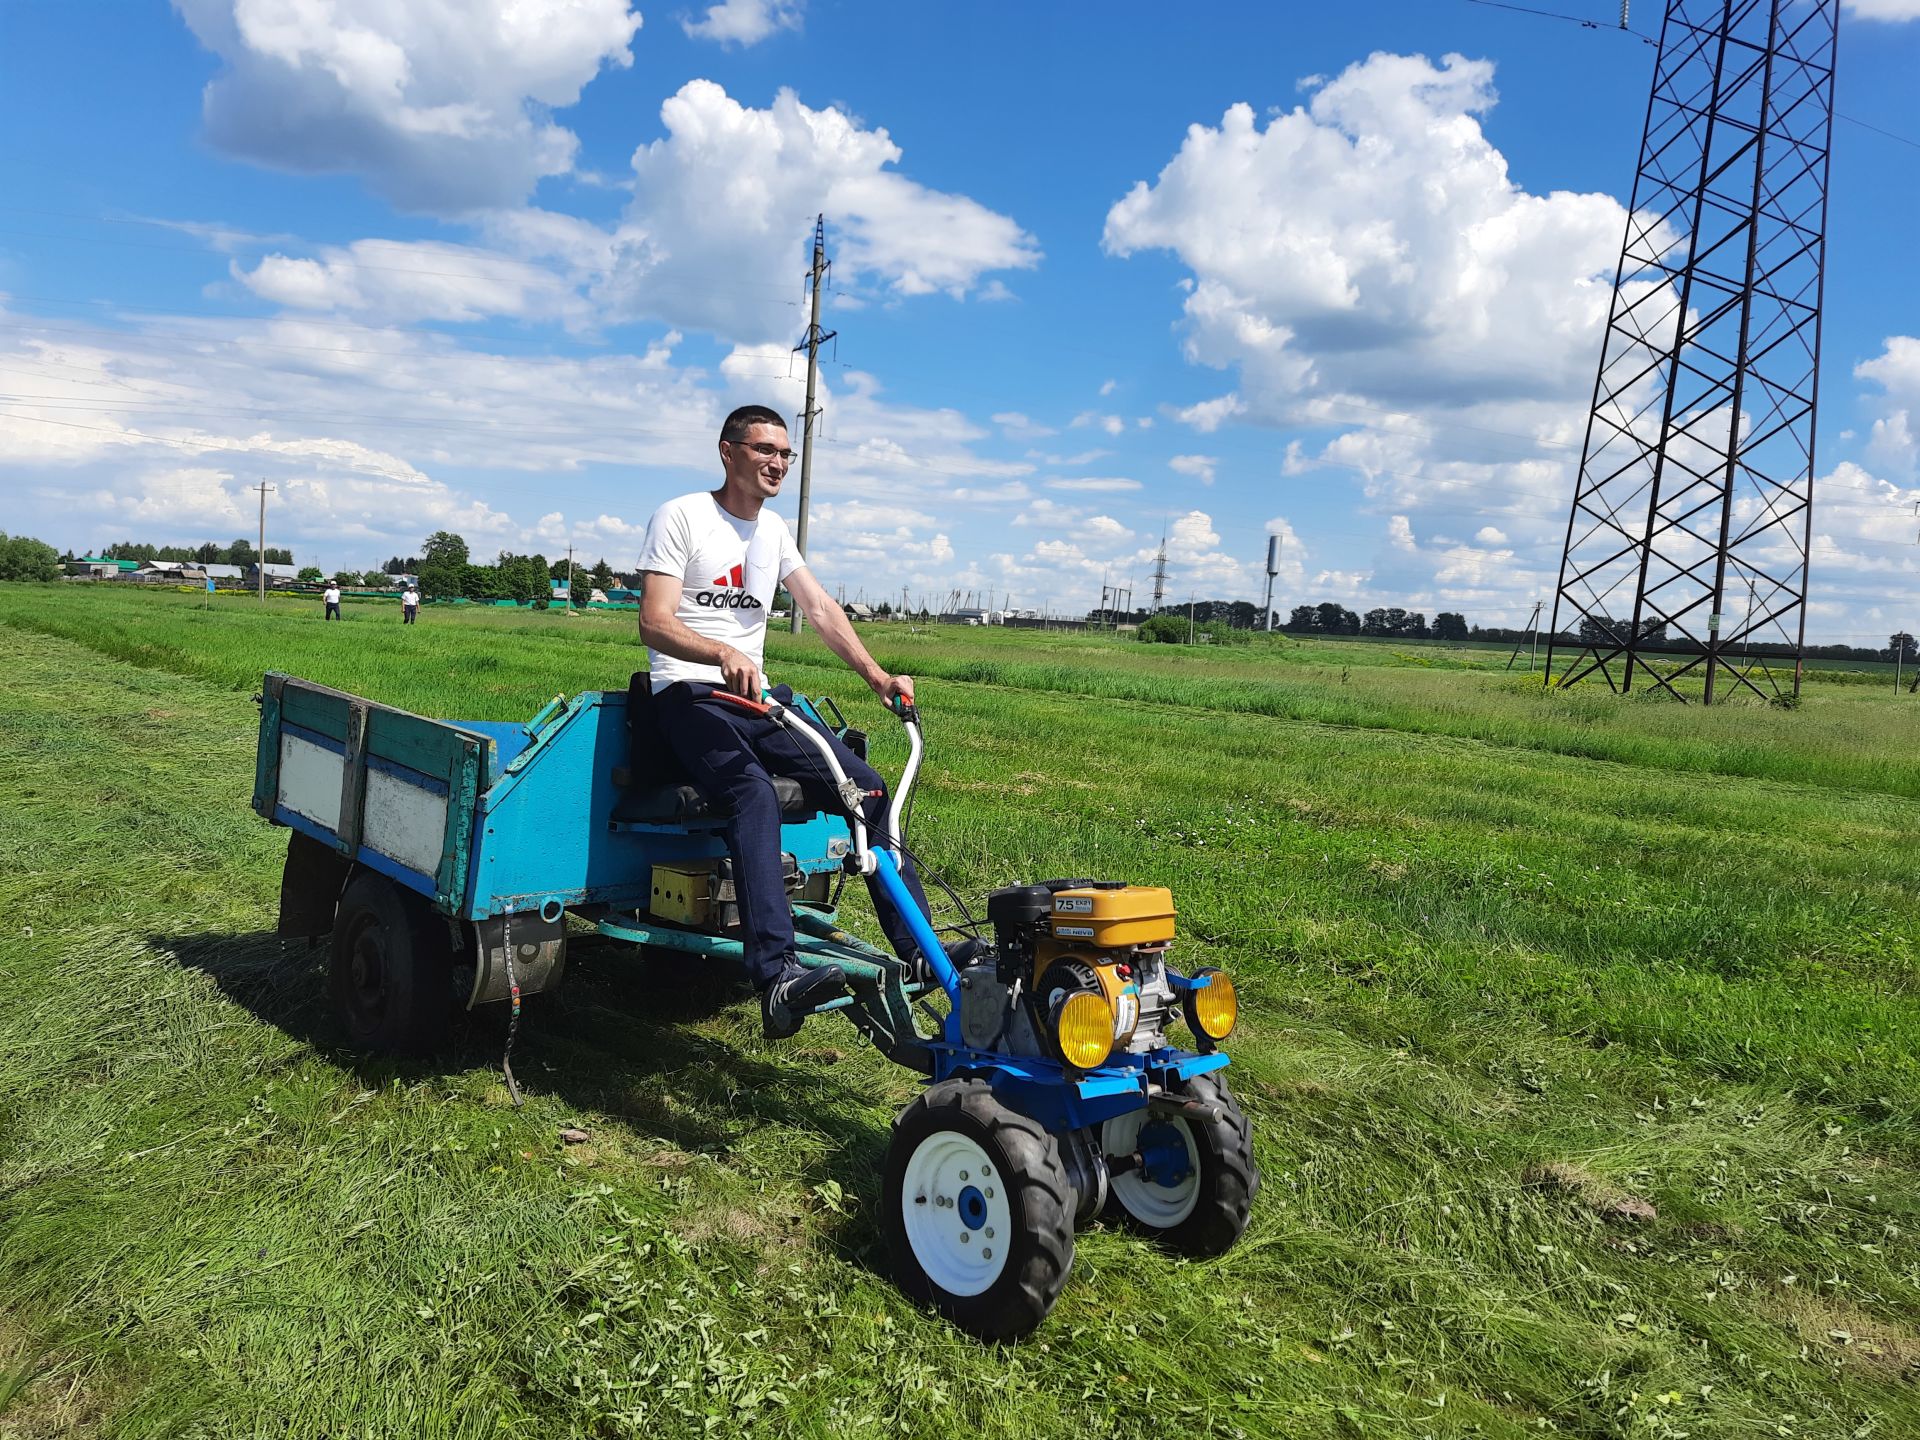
[639,492,806,693]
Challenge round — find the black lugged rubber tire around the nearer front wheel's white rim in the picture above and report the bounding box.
[885,1077,1073,1340]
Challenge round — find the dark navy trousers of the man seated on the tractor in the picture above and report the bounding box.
[653,682,927,987]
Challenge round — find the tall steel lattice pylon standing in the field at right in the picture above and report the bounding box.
[1548,0,1839,705]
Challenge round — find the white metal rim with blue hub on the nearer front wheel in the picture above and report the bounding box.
[899,1131,1014,1296]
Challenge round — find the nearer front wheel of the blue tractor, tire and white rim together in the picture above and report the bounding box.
[885,1079,1073,1340]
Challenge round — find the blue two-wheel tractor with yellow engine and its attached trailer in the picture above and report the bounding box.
[253,672,1260,1338]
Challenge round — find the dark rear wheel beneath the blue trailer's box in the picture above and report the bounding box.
[328,870,453,1056]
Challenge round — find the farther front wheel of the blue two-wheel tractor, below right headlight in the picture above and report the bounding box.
[1100,1075,1260,1256]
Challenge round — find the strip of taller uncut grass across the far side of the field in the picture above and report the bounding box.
[0,586,1920,799]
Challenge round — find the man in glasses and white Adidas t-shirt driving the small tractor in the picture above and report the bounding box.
[639,405,927,1037]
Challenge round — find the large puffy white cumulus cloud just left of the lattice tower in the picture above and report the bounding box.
[1104,54,1626,419]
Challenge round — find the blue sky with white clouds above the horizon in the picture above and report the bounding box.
[0,0,1920,643]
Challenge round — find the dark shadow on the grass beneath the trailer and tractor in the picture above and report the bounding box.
[146,931,891,1275]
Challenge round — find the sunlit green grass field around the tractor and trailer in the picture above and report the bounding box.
[0,586,1920,1440]
